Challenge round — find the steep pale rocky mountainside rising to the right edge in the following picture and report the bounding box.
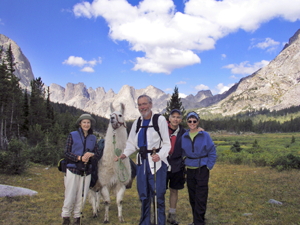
[199,30,300,115]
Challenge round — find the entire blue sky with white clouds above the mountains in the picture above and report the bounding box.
[0,0,300,96]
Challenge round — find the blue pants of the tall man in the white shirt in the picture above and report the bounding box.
[137,159,167,225]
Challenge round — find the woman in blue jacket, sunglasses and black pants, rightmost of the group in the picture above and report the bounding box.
[181,112,217,225]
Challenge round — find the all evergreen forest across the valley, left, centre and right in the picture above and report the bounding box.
[0,43,300,174]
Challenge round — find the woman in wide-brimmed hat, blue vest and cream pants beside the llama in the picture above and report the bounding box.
[61,114,100,225]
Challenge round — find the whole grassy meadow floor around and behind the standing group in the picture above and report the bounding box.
[0,133,300,225]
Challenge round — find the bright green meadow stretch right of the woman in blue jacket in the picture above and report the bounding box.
[211,132,300,170]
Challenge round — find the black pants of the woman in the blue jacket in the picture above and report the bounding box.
[187,166,209,225]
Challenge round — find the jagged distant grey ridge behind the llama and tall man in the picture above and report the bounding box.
[50,83,170,120]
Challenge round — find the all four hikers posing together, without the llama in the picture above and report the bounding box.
[61,95,216,225]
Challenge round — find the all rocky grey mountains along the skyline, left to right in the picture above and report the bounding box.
[0,30,300,120]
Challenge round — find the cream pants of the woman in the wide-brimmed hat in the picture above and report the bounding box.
[61,169,91,218]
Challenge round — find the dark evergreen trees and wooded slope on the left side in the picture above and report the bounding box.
[0,45,108,173]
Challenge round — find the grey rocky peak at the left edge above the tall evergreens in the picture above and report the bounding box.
[0,34,34,89]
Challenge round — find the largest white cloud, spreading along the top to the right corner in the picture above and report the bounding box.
[73,0,300,74]
